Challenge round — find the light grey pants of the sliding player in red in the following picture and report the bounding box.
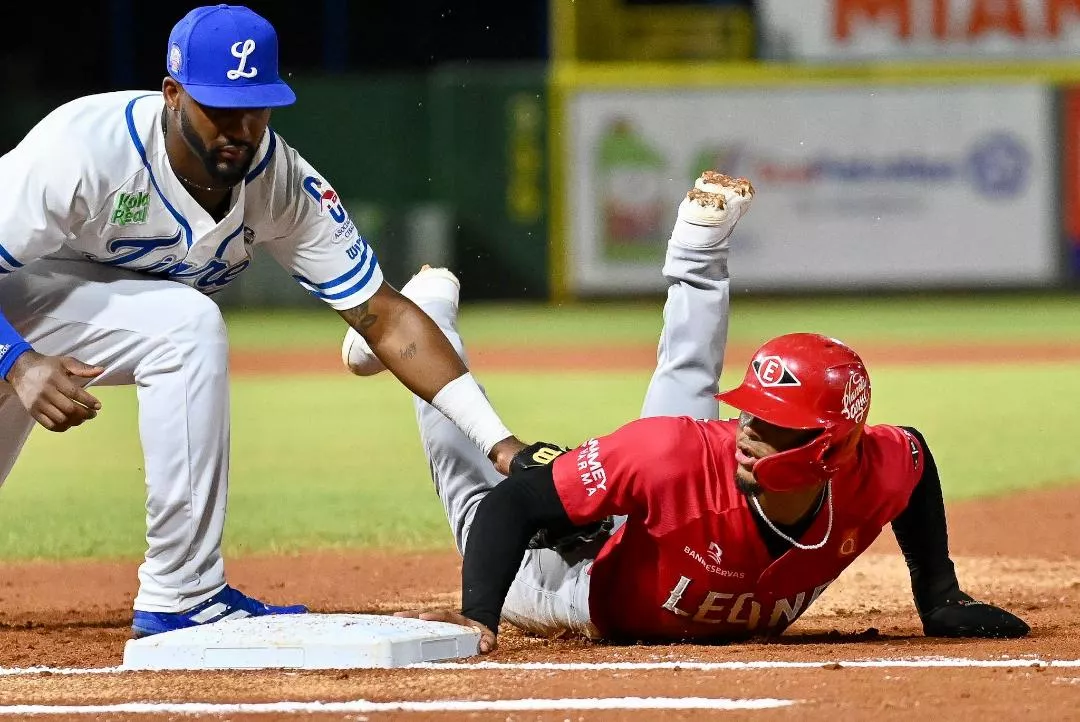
[413,215,729,637]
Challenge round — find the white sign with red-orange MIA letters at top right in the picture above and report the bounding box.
[758,0,1080,62]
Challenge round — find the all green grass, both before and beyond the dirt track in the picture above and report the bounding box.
[0,298,1080,559]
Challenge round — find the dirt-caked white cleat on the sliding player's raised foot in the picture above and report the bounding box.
[672,171,754,247]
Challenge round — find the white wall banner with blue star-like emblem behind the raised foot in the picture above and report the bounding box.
[564,84,1059,295]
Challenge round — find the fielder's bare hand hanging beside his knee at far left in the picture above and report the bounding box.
[8,351,105,432]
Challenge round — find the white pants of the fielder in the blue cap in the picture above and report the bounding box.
[0,259,229,612]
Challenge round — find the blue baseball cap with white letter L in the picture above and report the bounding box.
[165,5,296,108]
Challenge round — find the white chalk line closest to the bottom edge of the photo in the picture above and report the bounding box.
[0,697,795,717]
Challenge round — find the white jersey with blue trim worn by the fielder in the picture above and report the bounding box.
[0,91,382,310]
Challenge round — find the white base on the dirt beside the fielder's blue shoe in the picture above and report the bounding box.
[123,614,480,669]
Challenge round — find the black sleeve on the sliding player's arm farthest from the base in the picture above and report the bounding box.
[892,428,960,613]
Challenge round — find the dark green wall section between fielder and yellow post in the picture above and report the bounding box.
[228,64,549,305]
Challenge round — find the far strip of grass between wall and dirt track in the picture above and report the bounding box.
[229,294,1080,349]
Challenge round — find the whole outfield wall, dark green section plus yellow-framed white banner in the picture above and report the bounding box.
[10,62,1080,306]
